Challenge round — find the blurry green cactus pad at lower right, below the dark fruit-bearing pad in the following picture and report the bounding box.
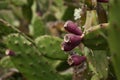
[85,48,108,80]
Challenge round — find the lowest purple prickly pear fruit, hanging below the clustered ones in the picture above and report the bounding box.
[68,54,86,66]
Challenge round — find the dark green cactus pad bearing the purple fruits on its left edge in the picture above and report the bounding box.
[83,29,108,50]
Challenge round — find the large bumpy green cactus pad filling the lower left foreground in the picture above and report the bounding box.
[6,34,64,80]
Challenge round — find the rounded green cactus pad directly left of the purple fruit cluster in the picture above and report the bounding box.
[35,35,67,60]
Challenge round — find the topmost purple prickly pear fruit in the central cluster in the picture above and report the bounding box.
[64,20,82,35]
